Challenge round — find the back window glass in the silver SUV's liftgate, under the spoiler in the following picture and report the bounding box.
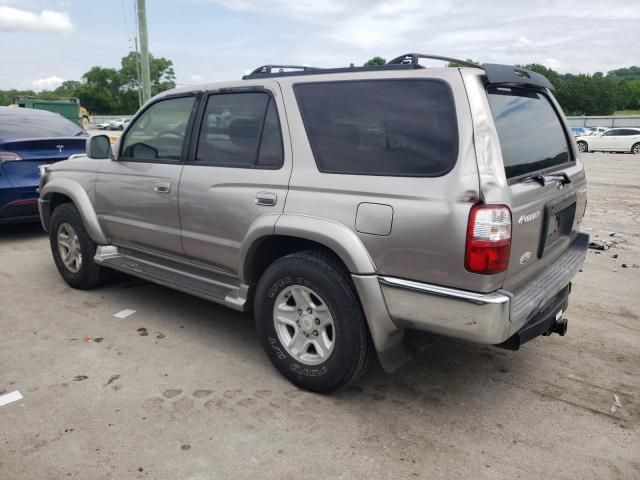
[487,87,571,178]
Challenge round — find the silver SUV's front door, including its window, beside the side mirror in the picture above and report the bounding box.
[96,94,198,255]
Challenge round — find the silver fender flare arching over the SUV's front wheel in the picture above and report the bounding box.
[40,178,109,245]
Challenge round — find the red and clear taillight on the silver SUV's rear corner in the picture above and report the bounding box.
[464,205,511,275]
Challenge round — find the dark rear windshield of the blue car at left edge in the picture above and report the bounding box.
[0,108,86,140]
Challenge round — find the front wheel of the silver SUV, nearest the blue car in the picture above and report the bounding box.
[49,203,108,290]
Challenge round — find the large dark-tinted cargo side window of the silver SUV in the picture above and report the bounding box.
[294,79,458,177]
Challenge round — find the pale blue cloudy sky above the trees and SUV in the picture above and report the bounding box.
[0,0,640,90]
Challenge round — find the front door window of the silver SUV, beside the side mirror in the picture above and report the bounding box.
[122,96,195,162]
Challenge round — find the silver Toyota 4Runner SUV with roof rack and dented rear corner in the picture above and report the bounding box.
[39,54,588,392]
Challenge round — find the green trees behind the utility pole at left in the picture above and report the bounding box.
[0,52,176,115]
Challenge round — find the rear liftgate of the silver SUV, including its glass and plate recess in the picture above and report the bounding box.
[487,86,586,288]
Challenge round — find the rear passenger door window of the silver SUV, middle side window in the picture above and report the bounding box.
[195,92,283,168]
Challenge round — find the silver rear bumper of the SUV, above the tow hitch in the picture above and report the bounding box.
[379,233,589,345]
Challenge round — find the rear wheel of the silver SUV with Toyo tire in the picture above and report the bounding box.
[255,251,373,393]
